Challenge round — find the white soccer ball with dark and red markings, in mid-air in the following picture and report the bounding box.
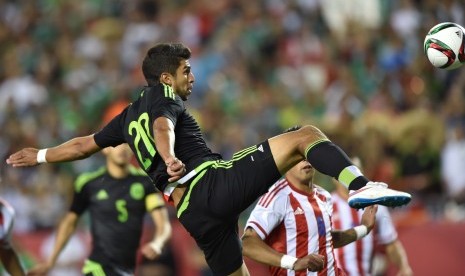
[423,22,465,70]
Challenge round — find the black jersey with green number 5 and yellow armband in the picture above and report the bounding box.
[70,165,164,270]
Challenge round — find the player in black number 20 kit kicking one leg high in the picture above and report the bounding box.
[7,43,411,275]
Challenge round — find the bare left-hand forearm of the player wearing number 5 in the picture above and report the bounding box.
[28,212,79,275]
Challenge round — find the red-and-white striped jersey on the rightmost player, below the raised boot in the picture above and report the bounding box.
[332,193,397,276]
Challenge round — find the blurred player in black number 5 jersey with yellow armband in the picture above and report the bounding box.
[28,144,171,276]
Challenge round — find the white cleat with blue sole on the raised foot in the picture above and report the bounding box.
[348,181,412,209]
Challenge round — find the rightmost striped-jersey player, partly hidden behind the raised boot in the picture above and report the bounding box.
[332,179,412,276]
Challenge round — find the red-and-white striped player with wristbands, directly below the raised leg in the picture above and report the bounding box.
[242,157,377,275]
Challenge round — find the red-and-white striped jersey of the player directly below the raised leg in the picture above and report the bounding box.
[246,179,340,275]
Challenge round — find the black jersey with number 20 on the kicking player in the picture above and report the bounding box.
[94,84,221,191]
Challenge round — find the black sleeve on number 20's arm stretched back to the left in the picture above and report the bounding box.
[94,107,128,148]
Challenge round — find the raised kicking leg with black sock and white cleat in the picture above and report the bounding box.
[269,126,411,208]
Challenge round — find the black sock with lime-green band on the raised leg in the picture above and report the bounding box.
[305,140,369,190]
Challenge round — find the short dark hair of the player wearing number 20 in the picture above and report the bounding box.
[142,43,191,86]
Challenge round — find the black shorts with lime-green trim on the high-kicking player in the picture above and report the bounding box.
[177,141,281,275]
